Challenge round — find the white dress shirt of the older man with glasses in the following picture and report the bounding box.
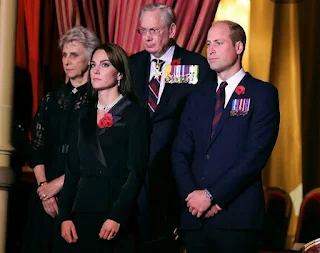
[149,46,175,104]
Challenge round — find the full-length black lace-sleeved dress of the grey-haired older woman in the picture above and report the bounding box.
[23,83,88,253]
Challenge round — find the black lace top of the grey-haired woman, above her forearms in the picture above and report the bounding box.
[29,83,88,181]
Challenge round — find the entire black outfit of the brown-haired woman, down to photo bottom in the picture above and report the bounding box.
[59,97,150,253]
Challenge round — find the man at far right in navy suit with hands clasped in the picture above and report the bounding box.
[172,21,280,253]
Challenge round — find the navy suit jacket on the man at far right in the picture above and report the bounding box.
[172,73,280,229]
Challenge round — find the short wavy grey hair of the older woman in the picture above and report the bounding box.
[58,26,100,59]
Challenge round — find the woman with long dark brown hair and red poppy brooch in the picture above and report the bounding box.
[59,43,150,253]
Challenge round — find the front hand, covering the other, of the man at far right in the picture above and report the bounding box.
[185,190,211,218]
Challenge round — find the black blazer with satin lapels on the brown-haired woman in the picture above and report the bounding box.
[59,97,150,227]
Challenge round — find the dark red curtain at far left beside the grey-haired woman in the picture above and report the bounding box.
[15,0,63,119]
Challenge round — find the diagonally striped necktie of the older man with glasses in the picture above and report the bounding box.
[148,59,165,116]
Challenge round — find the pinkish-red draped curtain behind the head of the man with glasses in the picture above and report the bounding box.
[56,0,219,54]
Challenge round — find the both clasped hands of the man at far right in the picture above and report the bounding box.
[185,190,221,218]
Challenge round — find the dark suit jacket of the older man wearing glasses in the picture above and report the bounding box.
[131,44,215,231]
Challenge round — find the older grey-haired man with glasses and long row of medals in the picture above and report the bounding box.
[131,3,214,253]
